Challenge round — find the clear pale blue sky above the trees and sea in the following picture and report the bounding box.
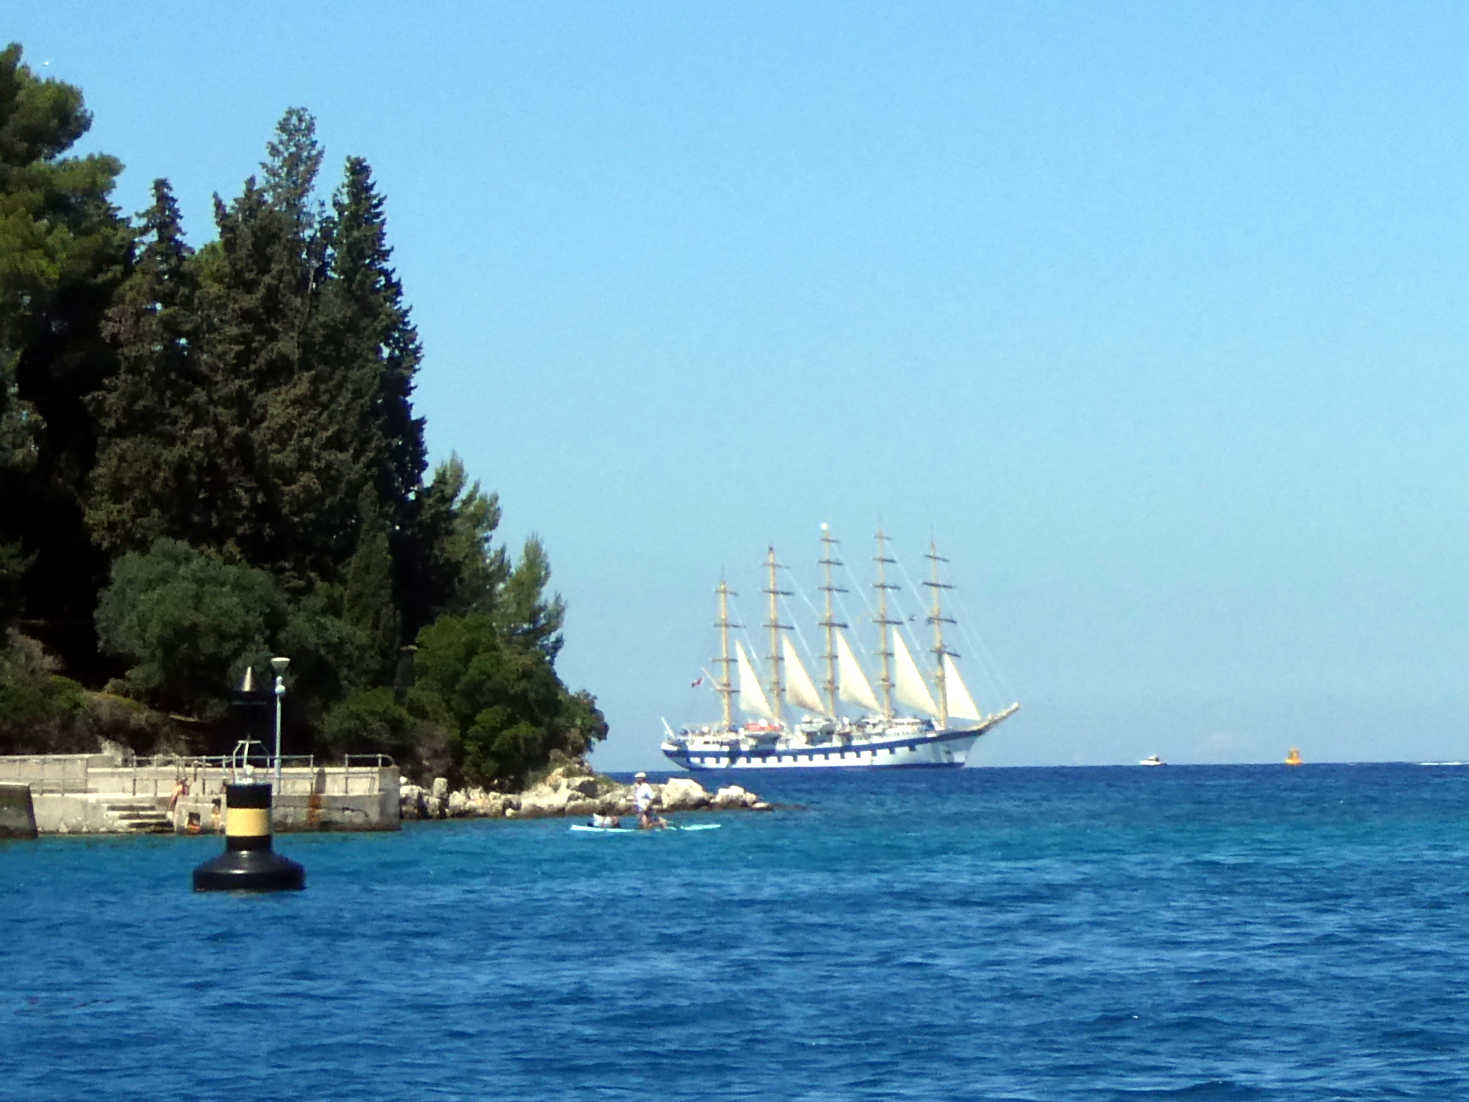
[17,0,1469,770]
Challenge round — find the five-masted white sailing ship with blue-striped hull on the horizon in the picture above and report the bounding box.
[663,525,1019,770]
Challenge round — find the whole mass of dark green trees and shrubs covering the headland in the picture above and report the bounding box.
[0,44,607,786]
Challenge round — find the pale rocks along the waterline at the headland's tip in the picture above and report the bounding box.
[400,763,771,821]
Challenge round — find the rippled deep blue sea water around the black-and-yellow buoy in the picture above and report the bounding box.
[0,763,1469,1102]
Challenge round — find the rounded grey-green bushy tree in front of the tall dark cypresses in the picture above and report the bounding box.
[97,539,286,717]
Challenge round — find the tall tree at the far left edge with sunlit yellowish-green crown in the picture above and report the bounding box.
[0,44,129,663]
